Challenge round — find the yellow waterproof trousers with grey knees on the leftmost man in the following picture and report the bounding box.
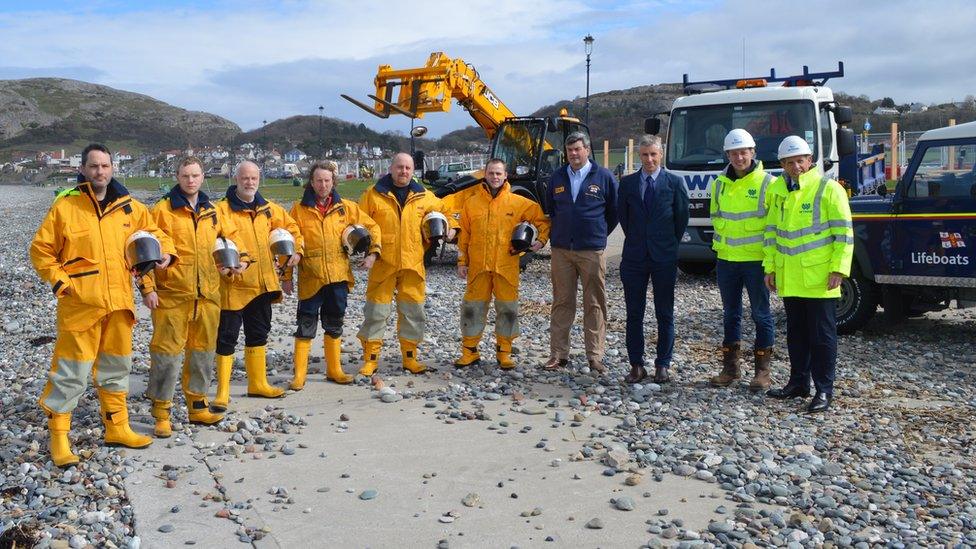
[40,309,135,414]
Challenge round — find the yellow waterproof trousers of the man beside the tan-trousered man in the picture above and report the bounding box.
[461,271,519,338]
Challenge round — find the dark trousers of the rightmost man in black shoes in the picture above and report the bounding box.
[783,297,837,395]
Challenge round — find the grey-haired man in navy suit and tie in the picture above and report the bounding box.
[617,135,689,383]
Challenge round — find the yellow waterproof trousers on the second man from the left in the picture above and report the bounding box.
[146,299,220,401]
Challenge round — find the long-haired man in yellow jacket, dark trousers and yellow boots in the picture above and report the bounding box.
[284,162,380,391]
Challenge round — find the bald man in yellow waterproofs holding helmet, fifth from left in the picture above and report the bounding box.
[358,153,454,376]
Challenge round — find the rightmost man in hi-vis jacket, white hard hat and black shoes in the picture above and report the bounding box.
[763,135,854,413]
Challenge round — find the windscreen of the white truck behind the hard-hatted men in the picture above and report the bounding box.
[666,101,819,171]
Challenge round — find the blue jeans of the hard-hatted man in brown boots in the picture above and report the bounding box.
[715,259,775,349]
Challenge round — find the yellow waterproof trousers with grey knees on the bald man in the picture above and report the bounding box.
[358,269,427,344]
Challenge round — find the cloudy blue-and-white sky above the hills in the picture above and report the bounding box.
[0,0,976,137]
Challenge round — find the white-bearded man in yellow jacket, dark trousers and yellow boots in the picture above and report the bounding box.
[211,161,302,412]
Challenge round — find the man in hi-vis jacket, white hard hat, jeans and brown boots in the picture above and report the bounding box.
[710,128,775,391]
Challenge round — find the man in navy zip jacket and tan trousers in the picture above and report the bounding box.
[545,132,617,373]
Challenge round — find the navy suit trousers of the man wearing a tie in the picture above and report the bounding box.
[620,257,678,368]
